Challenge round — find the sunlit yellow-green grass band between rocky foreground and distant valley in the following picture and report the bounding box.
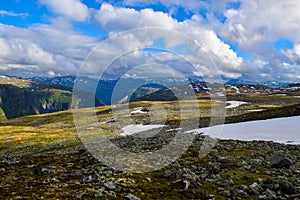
[0,100,295,156]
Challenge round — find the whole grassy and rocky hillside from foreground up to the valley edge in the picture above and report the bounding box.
[0,96,300,199]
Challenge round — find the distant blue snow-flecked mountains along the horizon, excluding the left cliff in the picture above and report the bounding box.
[29,76,300,105]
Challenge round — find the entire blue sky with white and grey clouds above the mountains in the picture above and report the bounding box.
[0,0,300,82]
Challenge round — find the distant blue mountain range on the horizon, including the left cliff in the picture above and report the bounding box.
[0,76,300,120]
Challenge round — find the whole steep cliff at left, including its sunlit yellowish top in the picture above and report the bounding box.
[0,76,101,120]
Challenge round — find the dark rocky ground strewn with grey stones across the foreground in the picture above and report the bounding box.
[0,133,300,200]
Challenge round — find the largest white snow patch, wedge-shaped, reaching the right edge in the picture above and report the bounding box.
[186,116,300,145]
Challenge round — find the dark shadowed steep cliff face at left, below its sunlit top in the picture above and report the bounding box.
[0,85,72,120]
